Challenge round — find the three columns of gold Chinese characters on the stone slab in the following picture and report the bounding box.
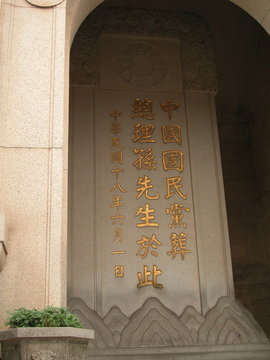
[103,97,191,289]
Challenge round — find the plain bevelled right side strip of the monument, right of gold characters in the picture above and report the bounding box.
[186,94,233,313]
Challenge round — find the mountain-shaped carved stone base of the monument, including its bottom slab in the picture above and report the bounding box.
[70,296,270,360]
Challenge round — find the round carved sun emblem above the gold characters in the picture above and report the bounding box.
[115,43,167,87]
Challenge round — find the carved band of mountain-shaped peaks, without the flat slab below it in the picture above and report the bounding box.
[69,296,270,348]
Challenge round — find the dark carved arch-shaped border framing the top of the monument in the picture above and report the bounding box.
[71,7,217,92]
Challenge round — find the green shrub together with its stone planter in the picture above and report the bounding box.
[0,307,94,360]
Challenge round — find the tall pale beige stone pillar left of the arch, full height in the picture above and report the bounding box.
[0,0,67,324]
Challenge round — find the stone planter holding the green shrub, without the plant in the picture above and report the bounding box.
[0,328,94,360]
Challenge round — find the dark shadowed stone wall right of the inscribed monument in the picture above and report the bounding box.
[212,12,270,334]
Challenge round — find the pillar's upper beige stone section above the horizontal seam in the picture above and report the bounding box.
[3,4,64,147]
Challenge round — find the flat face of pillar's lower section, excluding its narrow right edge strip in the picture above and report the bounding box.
[0,149,48,323]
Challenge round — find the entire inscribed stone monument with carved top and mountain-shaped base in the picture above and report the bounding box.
[69,8,270,360]
